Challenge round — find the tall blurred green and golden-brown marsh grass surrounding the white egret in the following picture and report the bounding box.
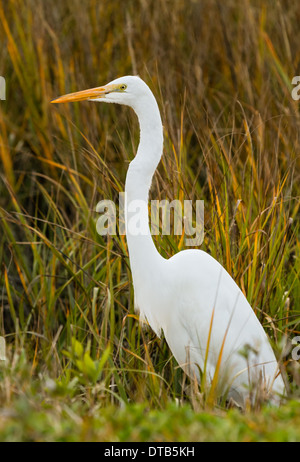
[0,0,300,440]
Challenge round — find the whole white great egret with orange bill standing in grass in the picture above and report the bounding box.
[52,76,285,405]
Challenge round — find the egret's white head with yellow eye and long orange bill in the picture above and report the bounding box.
[51,75,151,108]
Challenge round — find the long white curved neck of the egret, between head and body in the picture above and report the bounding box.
[125,90,163,274]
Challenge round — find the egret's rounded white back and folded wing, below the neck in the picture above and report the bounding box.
[157,249,284,404]
